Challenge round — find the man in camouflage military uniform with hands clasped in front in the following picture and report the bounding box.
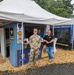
[29,29,41,65]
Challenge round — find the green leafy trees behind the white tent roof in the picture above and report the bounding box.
[35,0,73,18]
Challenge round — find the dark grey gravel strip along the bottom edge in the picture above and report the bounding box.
[0,63,74,75]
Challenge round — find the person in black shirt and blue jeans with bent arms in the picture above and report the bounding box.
[43,30,54,61]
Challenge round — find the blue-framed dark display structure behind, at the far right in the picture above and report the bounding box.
[51,25,74,44]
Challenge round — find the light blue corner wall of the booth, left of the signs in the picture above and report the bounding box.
[10,23,22,67]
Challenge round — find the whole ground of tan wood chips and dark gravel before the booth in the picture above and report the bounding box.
[0,49,74,75]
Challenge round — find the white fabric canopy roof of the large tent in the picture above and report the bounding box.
[0,0,73,25]
